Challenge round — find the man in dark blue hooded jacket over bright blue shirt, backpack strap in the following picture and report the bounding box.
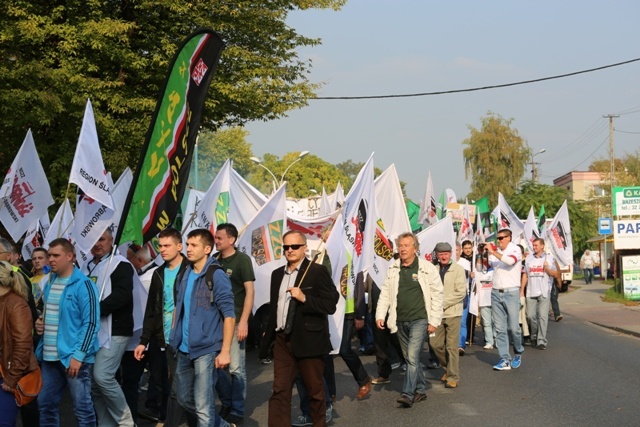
[170,228,236,427]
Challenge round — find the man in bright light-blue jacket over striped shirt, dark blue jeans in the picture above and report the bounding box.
[36,238,100,427]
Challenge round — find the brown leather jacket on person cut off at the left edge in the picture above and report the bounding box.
[0,292,38,388]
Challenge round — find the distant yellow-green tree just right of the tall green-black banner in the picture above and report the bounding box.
[190,127,255,190]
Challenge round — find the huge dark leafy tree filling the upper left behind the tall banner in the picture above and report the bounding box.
[0,0,346,200]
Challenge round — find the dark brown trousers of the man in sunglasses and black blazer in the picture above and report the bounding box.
[269,332,327,427]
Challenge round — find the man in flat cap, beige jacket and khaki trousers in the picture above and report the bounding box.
[430,242,467,388]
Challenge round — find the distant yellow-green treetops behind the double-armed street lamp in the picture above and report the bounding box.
[249,152,349,198]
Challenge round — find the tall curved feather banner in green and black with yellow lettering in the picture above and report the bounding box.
[115,29,224,244]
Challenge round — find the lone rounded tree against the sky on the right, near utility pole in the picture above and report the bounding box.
[462,111,531,205]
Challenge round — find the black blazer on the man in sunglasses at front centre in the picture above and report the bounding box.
[260,259,340,359]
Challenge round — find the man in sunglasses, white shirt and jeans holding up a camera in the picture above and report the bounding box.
[487,228,524,371]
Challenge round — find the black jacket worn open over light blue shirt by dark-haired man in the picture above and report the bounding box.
[140,255,189,348]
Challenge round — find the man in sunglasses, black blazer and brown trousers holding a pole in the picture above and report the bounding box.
[260,230,339,427]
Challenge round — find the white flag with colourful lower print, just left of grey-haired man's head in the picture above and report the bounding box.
[369,164,411,287]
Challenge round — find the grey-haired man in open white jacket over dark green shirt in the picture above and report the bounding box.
[376,233,444,408]
